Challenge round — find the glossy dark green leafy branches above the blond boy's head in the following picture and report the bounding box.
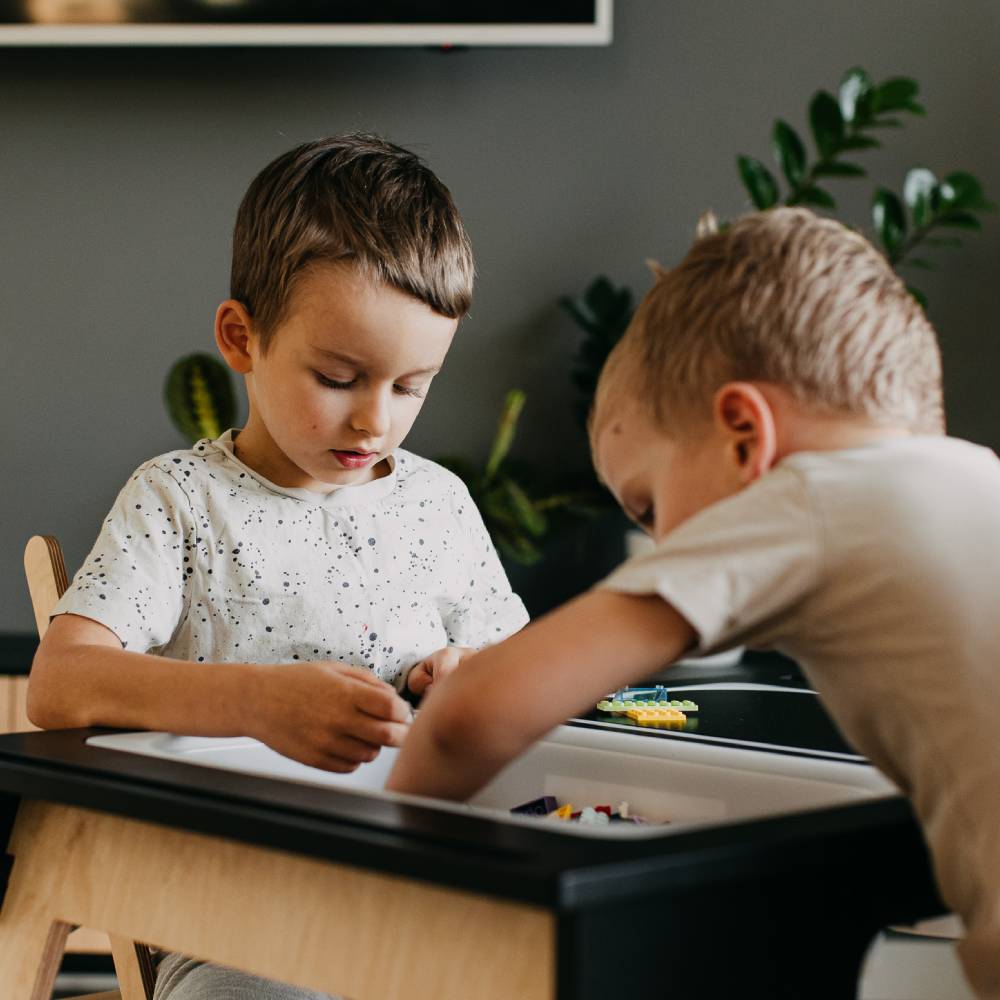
[736,67,995,308]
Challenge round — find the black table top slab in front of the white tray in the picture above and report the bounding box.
[0,729,936,915]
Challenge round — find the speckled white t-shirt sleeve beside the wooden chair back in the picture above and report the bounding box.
[53,465,193,652]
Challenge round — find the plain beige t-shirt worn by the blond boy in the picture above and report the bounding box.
[601,437,1000,997]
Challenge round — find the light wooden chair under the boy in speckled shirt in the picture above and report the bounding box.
[24,535,156,1000]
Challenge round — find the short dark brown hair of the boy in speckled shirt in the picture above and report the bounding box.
[230,133,475,350]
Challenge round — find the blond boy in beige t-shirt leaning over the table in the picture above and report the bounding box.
[390,209,1000,998]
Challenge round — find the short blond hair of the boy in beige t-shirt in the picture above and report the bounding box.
[592,208,944,434]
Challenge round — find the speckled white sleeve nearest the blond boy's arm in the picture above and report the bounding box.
[441,480,528,649]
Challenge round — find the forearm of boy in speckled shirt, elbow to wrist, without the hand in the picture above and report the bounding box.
[28,644,260,736]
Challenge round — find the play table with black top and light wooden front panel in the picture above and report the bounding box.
[0,712,941,1000]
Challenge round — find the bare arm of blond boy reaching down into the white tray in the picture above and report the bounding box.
[386,590,695,799]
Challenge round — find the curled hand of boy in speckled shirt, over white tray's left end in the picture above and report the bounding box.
[244,662,411,773]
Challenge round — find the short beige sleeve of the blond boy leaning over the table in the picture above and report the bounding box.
[598,467,822,653]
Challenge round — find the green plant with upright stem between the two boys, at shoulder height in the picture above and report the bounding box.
[437,389,595,565]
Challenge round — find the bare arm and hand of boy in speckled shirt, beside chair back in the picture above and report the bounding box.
[28,614,410,771]
